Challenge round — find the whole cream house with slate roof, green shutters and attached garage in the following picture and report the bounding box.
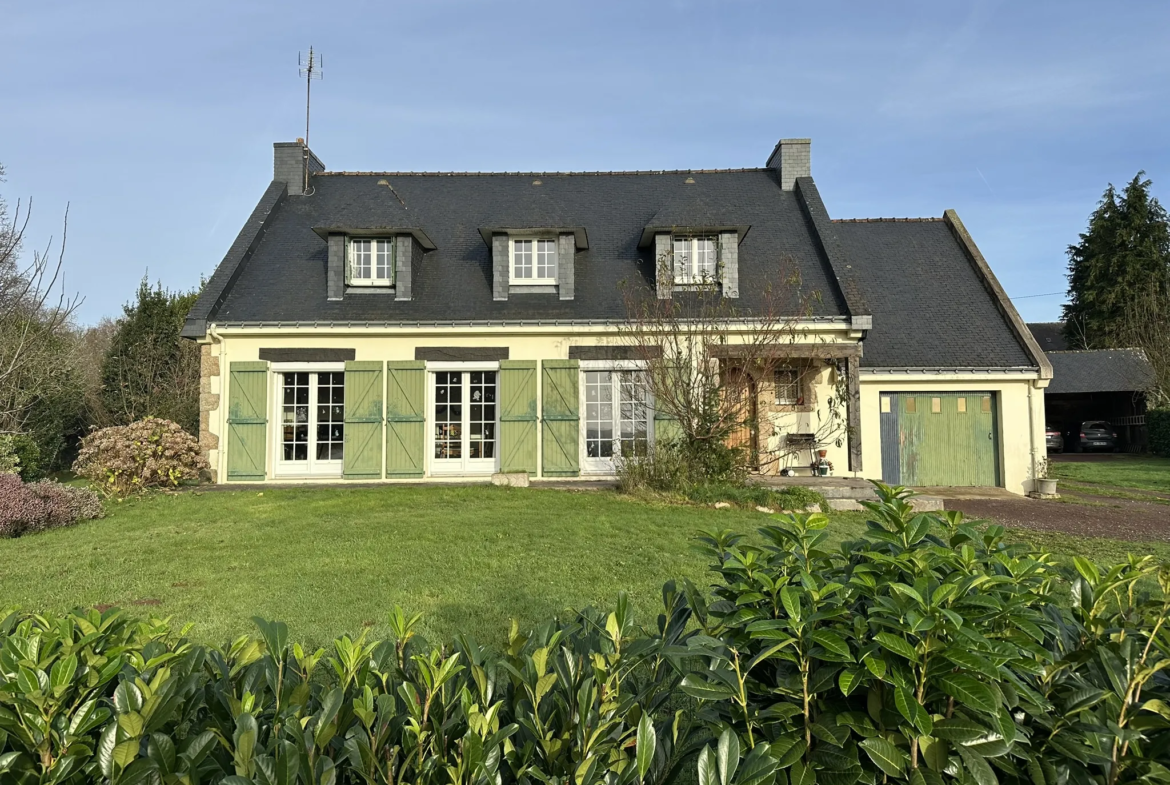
[184,139,1052,494]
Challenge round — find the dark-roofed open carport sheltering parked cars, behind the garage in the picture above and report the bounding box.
[1027,322,1154,453]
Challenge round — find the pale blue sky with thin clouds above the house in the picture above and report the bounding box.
[0,0,1170,323]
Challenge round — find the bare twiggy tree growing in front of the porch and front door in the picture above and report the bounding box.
[621,251,847,468]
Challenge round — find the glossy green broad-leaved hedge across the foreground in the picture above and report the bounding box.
[0,487,1170,785]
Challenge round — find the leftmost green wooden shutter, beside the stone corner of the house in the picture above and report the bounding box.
[227,361,268,482]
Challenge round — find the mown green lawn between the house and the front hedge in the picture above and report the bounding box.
[0,487,1170,643]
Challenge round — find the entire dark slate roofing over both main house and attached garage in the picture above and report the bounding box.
[184,155,1038,369]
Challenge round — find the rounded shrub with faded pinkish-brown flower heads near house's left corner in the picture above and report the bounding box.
[74,418,208,496]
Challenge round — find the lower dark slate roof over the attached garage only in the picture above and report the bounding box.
[833,219,1035,367]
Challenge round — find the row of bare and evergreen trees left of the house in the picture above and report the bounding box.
[0,166,199,476]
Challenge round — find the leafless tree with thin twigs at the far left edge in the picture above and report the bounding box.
[0,167,81,433]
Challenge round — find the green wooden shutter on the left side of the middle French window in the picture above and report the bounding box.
[386,360,427,477]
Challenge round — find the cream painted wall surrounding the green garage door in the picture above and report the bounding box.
[861,373,1046,494]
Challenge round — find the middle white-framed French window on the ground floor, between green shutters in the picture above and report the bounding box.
[431,371,498,475]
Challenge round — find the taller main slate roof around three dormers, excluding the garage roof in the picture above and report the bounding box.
[205,170,847,323]
